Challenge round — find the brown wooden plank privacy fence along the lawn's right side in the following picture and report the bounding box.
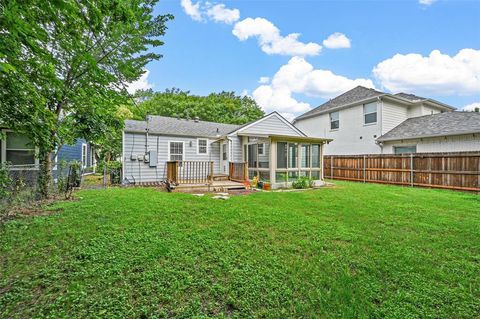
[323,152,480,192]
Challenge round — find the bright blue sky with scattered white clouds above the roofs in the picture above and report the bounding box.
[128,0,480,118]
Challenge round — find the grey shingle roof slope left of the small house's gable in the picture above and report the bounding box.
[125,116,239,137]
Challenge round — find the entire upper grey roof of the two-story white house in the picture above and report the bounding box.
[294,86,455,123]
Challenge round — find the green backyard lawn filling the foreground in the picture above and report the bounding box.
[0,182,480,318]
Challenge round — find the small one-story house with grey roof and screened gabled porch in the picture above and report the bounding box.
[122,112,329,188]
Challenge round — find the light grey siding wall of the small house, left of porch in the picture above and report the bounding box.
[123,132,220,183]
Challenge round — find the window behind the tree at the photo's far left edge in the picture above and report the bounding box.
[5,132,36,165]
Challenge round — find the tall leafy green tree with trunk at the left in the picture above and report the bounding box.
[0,0,172,197]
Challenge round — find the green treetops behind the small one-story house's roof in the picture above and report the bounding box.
[130,89,264,124]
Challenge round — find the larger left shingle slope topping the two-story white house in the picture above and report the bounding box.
[295,86,386,120]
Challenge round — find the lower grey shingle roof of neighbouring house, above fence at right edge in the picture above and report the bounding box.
[377,112,480,142]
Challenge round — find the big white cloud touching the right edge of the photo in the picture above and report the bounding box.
[373,49,480,95]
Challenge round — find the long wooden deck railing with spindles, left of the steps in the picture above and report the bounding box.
[167,161,213,184]
